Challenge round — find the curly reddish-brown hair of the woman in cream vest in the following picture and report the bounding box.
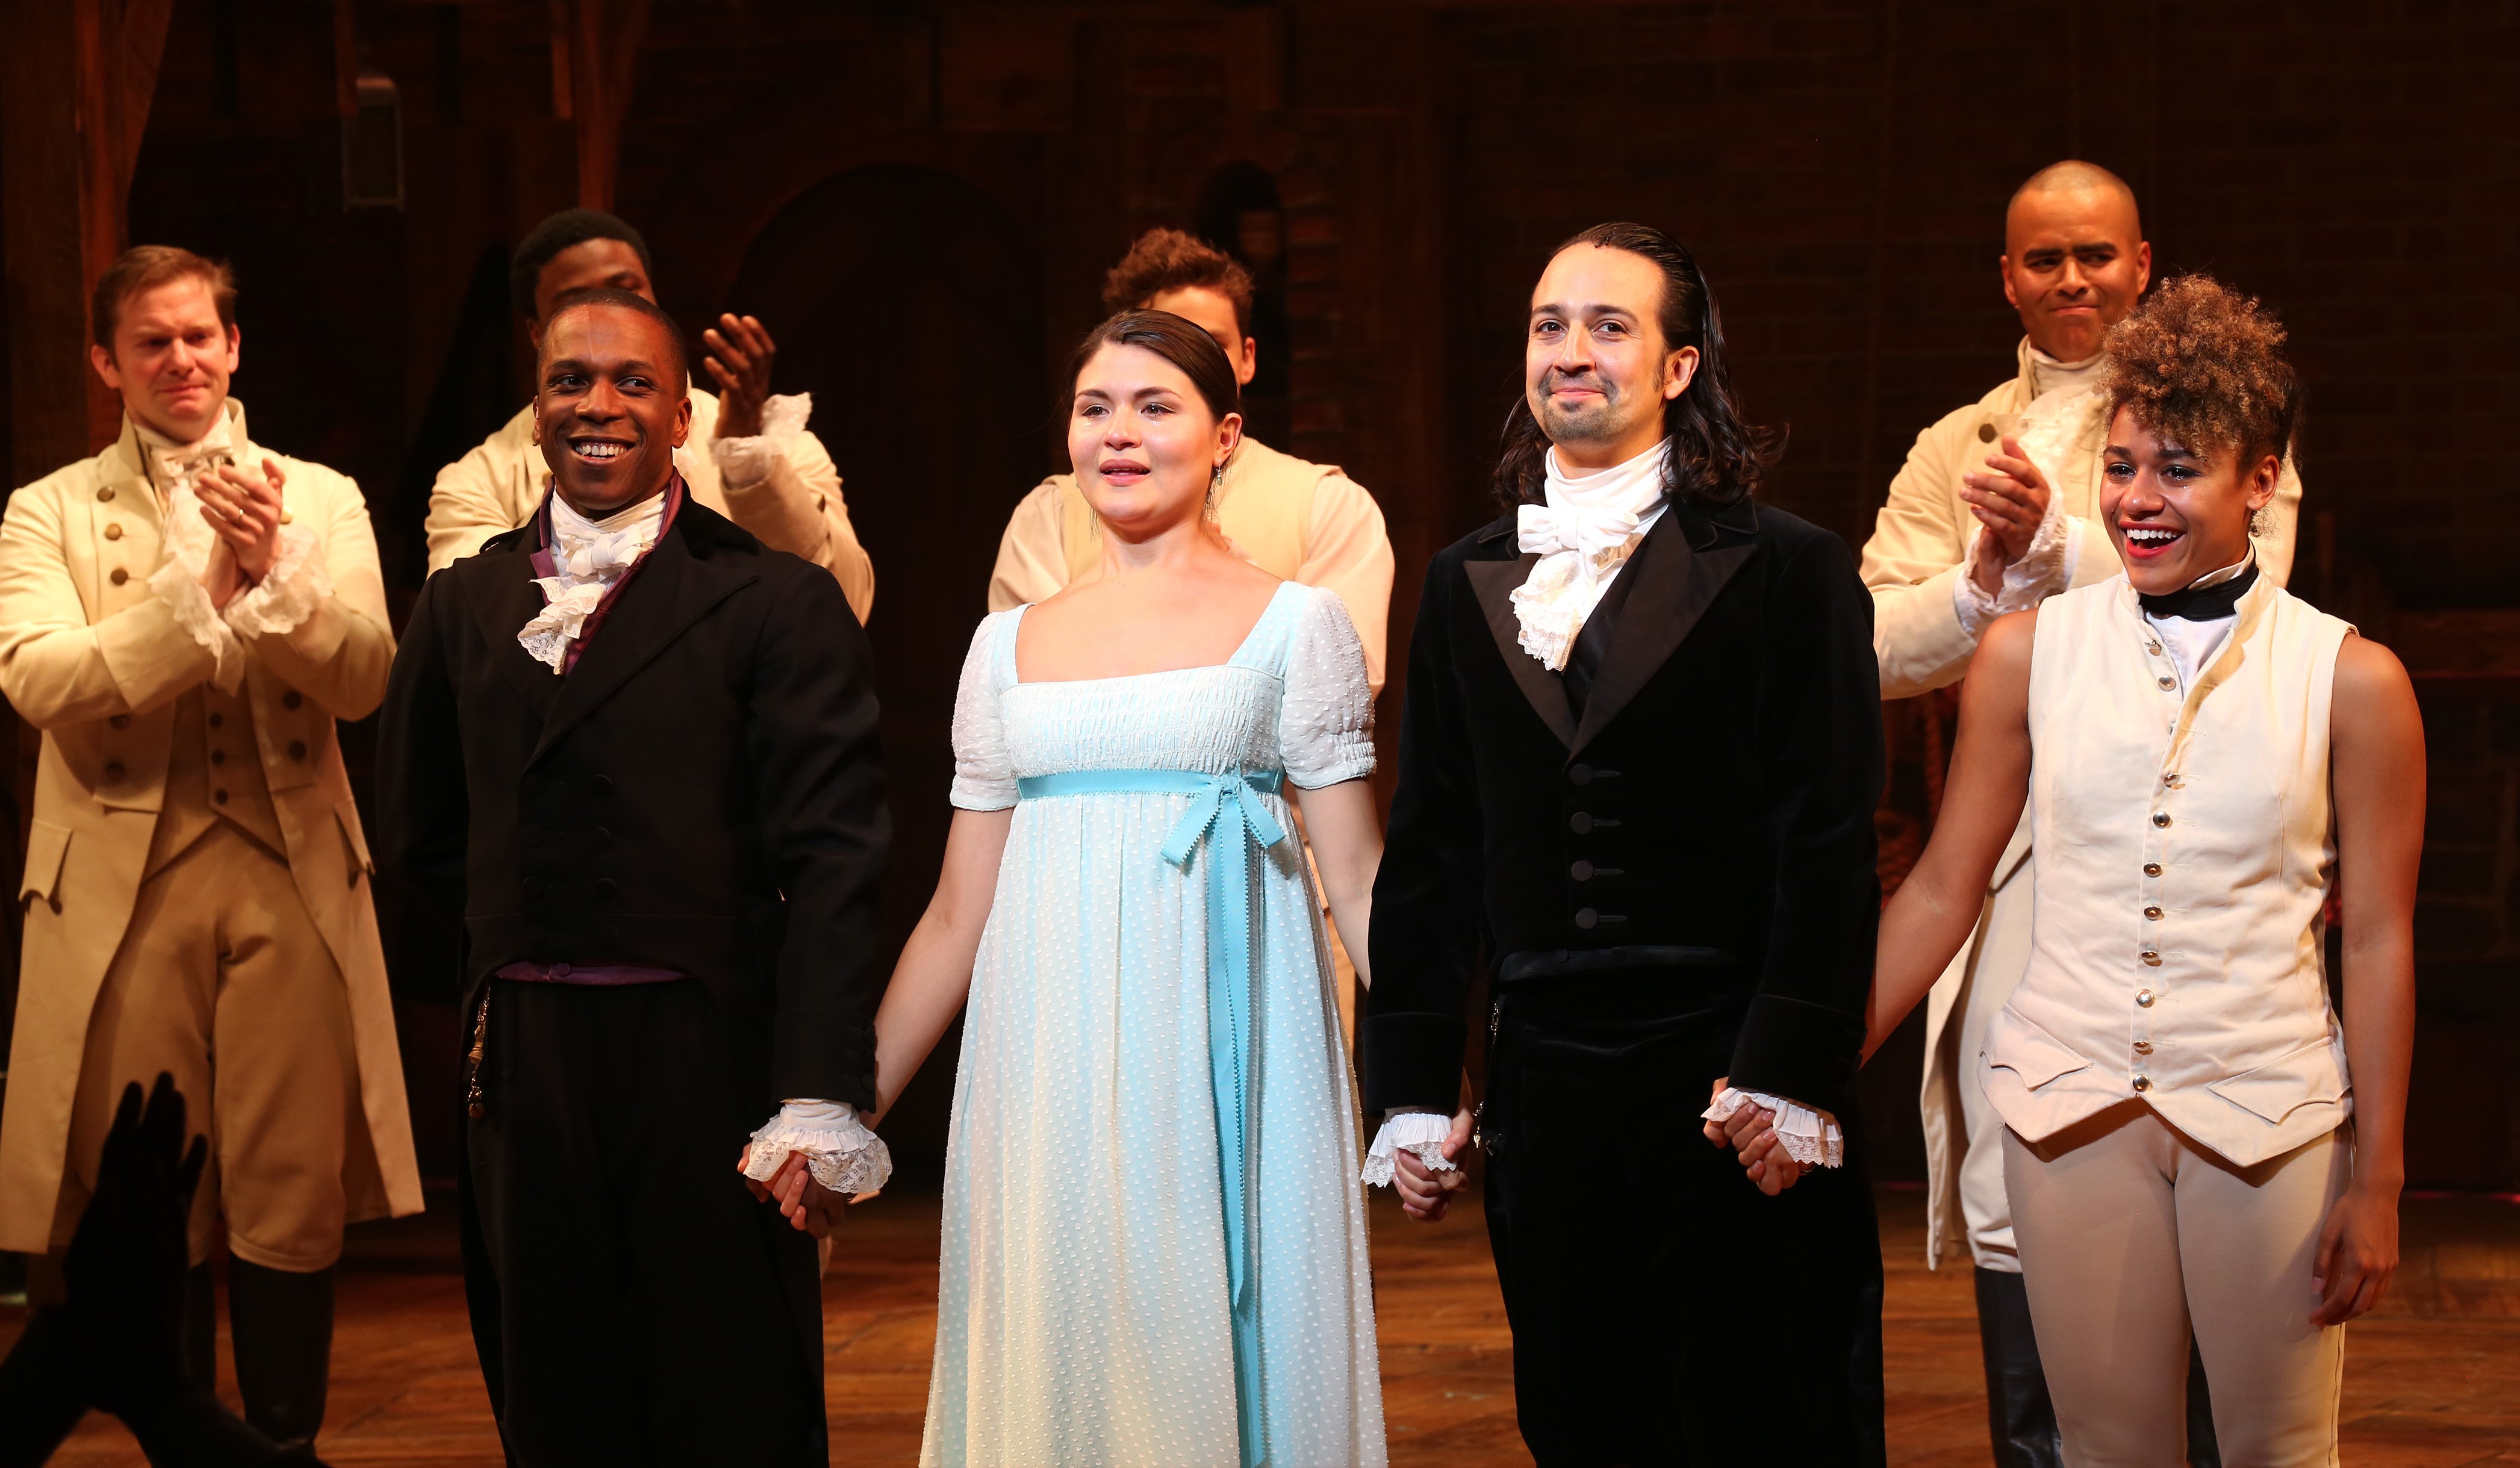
[2104,275,2301,458]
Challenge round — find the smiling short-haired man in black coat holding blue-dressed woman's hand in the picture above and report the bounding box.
[378,292,889,1468]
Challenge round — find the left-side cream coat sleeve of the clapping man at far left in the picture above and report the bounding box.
[0,488,217,730]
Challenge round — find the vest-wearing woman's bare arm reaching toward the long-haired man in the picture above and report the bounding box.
[1865,612,2039,1060]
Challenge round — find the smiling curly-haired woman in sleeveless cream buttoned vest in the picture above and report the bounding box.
[1870,277,2424,1468]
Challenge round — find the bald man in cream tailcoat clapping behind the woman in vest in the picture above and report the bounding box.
[1862,161,2301,1468]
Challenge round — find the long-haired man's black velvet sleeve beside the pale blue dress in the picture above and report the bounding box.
[1363,559,1487,1113]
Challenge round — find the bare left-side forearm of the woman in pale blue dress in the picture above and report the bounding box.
[874,811,1016,1118]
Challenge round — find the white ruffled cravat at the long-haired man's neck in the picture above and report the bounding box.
[1512,438,1671,673]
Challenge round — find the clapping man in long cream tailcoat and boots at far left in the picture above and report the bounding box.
[0,247,421,1443]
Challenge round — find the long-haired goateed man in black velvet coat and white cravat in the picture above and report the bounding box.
[1363,224,1882,1468]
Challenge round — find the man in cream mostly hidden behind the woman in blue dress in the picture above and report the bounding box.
[988,229,1391,692]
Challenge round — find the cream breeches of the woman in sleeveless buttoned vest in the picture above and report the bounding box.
[2003,1100,2354,1468]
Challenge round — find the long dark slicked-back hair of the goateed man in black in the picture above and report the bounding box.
[1492,224,1784,506]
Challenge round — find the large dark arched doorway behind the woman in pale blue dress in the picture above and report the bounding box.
[728,166,1051,1163]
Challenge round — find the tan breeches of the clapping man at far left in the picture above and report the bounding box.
[53,821,378,1272]
